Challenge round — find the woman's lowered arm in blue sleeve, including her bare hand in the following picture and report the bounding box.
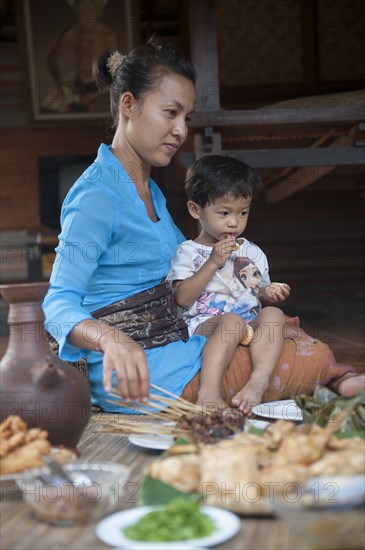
[43,178,149,401]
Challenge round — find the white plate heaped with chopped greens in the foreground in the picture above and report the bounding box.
[96,498,240,550]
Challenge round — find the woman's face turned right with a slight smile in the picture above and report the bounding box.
[126,73,195,166]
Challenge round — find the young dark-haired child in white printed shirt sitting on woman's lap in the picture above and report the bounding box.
[167,155,290,415]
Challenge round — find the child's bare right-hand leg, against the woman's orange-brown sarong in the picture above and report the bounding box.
[232,306,285,414]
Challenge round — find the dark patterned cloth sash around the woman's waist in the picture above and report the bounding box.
[92,282,188,349]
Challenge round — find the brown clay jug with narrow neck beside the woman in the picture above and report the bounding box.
[0,283,91,447]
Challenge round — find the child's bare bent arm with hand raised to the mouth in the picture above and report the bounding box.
[172,238,234,307]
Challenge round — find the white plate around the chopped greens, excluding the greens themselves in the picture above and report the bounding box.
[96,506,241,550]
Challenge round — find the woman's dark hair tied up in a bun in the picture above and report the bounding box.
[93,35,195,126]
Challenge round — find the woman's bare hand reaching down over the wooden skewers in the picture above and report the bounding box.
[99,329,150,401]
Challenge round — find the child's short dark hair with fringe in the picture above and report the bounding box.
[185,155,261,208]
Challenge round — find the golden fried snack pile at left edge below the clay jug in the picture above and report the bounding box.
[0,415,51,475]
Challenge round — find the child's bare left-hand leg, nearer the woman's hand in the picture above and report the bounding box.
[195,313,246,408]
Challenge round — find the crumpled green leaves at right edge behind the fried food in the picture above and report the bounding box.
[293,386,365,435]
